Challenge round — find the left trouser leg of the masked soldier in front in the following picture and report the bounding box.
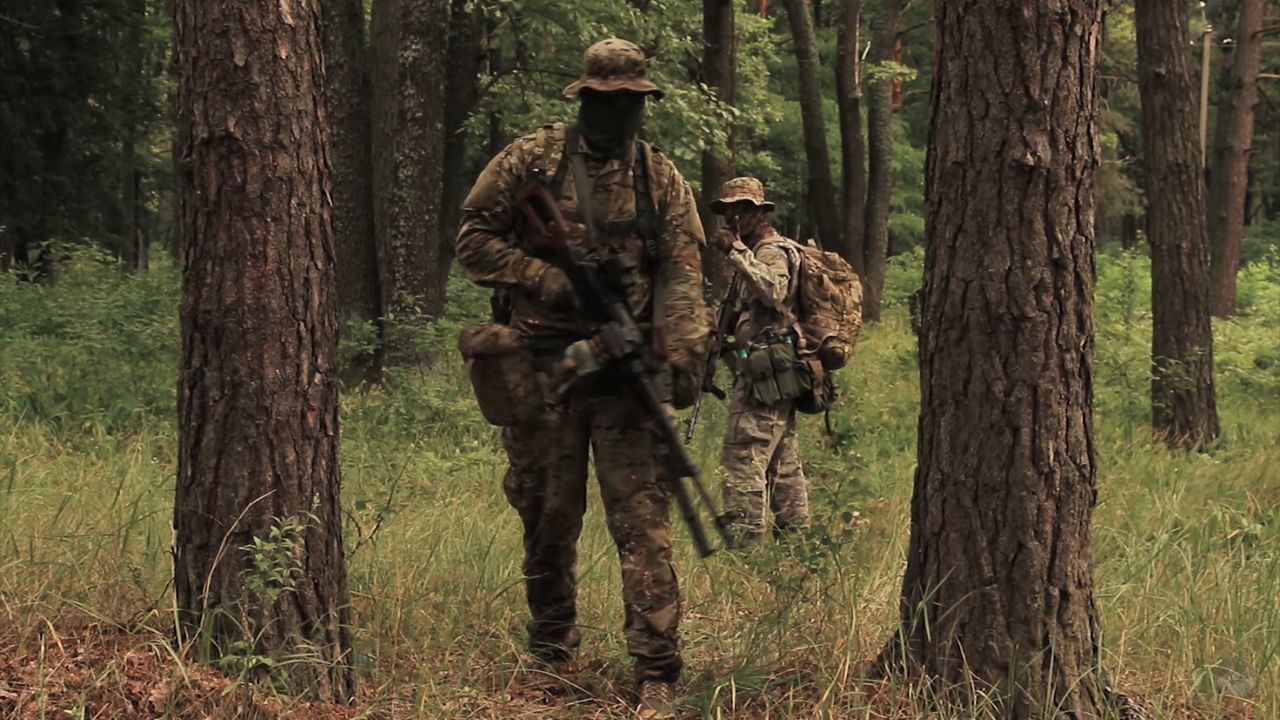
[502,399,588,661]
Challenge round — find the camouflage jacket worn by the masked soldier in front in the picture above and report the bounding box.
[457,123,710,373]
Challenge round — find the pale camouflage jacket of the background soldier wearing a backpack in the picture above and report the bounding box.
[728,228,800,347]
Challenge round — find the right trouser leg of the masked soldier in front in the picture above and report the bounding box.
[591,398,682,682]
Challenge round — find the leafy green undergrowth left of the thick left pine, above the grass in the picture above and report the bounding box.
[0,247,178,434]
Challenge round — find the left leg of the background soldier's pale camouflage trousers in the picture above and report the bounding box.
[717,383,786,544]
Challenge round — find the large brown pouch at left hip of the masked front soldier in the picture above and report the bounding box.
[458,323,547,428]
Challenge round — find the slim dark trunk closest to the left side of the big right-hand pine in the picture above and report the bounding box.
[863,0,902,323]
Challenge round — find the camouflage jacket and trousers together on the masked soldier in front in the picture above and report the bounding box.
[457,116,710,682]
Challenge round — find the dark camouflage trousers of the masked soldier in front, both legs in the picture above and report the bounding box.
[502,396,681,682]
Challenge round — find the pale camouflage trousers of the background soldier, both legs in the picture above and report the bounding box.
[718,382,809,544]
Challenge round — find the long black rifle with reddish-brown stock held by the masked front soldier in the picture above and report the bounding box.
[516,176,728,557]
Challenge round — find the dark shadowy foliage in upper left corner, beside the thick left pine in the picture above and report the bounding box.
[0,0,173,263]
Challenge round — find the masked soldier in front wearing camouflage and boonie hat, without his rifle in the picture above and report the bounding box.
[457,38,709,717]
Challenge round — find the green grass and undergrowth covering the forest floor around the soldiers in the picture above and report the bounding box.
[0,244,1280,719]
